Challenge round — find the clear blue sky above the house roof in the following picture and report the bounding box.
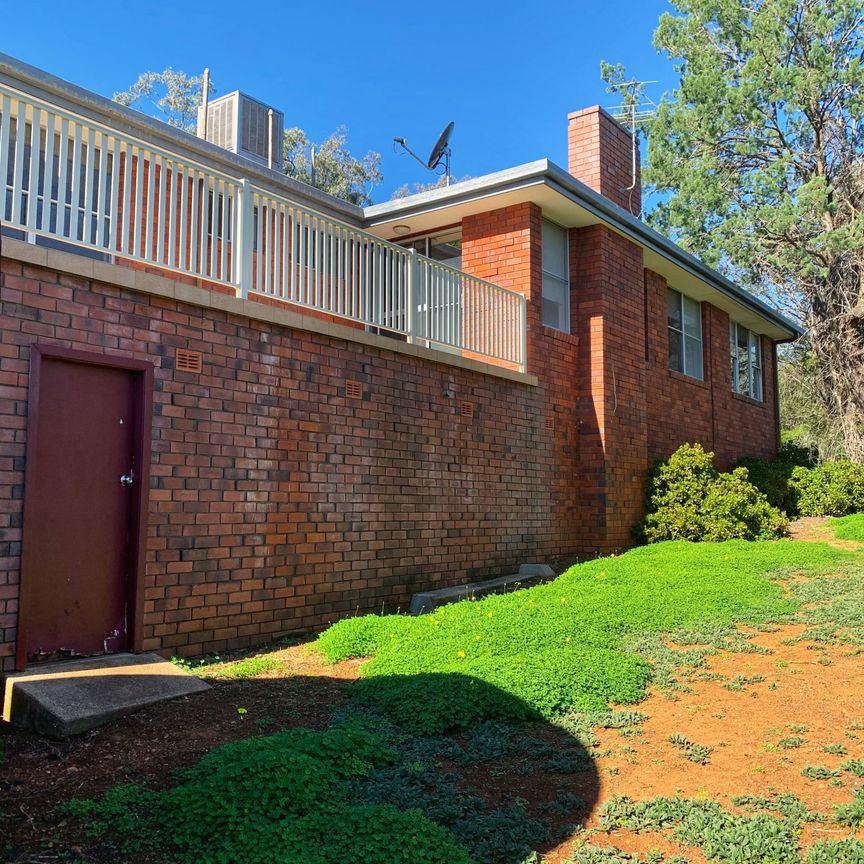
[8,0,675,201]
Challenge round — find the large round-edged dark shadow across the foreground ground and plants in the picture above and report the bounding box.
[0,666,600,864]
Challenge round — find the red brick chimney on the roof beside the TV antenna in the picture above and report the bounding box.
[567,105,642,216]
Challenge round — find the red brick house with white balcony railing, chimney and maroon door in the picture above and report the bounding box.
[0,55,796,671]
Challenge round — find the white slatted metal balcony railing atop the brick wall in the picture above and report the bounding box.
[0,84,525,370]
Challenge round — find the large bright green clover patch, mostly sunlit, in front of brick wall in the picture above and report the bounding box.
[316,541,854,734]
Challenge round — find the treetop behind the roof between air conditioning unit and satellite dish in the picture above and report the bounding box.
[282,126,382,205]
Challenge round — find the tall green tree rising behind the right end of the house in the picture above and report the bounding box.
[612,0,864,461]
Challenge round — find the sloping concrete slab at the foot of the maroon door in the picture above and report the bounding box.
[3,654,210,738]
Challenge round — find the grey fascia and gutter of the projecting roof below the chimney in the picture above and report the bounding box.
[364,159,803,341]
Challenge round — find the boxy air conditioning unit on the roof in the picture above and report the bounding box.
[198,90,285,171]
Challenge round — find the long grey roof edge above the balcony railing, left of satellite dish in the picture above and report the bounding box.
[0,52,363,225]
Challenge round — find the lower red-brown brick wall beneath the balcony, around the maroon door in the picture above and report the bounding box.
[0,253,578,670]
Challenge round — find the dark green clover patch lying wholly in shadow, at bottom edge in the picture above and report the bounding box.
[63,727,480,864]
